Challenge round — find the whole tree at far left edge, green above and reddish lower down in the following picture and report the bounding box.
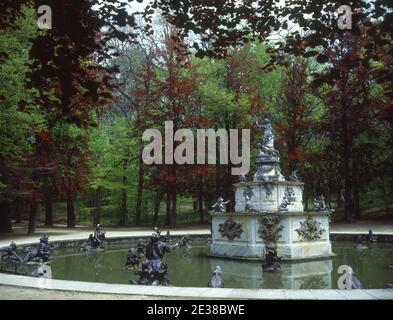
[0,7,45,232]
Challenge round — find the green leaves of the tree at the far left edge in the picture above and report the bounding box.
[0,7,45,179]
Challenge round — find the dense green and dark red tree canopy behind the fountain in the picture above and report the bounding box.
[0,0,393,232]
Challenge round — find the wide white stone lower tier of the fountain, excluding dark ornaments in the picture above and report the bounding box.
[210,212,333,260]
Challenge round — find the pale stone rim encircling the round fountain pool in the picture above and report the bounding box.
[0,232,393,300]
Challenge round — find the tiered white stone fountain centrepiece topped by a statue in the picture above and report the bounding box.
[210,119,333,260]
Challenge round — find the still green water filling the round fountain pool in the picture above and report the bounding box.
[12,242,393,289]
